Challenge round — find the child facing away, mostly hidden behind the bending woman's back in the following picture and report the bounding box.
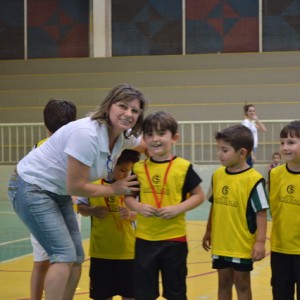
[30,98,77,300]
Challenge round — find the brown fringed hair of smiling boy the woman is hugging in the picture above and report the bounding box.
[142,111,178,136]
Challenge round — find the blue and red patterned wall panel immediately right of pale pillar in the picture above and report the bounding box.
[112,0,182,56]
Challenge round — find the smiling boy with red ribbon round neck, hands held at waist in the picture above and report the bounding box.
[125,111,205,300]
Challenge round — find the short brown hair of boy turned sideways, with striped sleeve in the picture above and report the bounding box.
[215,125,254,156]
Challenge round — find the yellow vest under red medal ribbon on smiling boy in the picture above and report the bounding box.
[133,157,190,241]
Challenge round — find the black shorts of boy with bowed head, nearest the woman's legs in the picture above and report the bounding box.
[90,257,134,300]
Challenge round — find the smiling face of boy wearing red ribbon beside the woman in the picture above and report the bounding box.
[144,130,179,160]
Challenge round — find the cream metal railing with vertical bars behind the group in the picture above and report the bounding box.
[0,119,292,165]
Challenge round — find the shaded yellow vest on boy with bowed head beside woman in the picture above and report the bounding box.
[89,181,135,259]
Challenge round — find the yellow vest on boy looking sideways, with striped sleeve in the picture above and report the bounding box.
[211,167,262,259]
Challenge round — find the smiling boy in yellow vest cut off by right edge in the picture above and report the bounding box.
[269,121,300,300]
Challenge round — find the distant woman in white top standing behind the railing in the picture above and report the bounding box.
[242,104,267,167]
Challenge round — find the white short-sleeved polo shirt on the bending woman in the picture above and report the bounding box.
[17,117,141,195]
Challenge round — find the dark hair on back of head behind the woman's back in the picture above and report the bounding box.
[44,98,77,134]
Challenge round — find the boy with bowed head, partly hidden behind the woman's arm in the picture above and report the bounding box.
[77,149,140,300]
